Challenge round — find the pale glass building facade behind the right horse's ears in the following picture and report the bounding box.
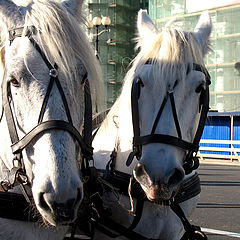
[149,0,240,112]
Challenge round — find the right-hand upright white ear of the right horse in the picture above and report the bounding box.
[193,11,212,55]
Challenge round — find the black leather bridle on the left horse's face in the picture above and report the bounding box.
[1,27,93,191]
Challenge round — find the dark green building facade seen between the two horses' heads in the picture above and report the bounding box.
[88,0,148,107]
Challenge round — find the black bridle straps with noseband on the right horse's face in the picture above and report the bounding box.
[126,61,211,174]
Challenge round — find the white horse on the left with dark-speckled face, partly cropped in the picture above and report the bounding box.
[0,0,102,240]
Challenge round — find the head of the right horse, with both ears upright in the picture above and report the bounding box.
[132,11,211,201]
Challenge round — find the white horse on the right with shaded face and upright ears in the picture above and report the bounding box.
[93,10,212,240]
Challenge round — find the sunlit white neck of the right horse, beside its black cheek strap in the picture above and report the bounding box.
[93,91,137,174]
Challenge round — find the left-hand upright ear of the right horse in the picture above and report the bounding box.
[137,9,159,46]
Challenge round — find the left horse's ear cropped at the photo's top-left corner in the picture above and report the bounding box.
[0,0,24,31]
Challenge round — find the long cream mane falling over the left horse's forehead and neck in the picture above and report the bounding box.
[0,0,103,108]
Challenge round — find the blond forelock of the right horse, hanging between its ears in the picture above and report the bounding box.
[124,27,204,94]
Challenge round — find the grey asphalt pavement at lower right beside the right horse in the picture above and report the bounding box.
[190,160,240,240]
